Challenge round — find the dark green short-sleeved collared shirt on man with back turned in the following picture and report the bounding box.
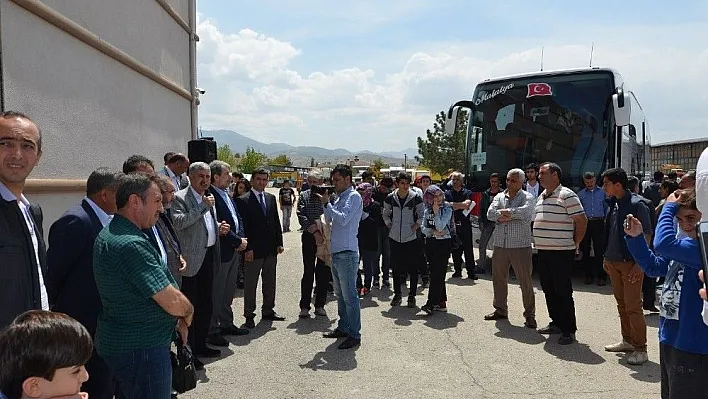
[93,215,178,357]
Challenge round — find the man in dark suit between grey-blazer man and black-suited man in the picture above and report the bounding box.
[207,161,248,346]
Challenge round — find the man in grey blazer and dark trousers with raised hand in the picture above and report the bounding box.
[172,162,230,360]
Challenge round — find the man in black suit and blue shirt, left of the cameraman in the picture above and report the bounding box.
[236,168,285,328]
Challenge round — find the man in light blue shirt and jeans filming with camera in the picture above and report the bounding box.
[317,164,363,349]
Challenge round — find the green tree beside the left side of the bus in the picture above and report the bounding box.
[415,110,468,174]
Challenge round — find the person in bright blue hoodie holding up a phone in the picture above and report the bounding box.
[624,188,708,398]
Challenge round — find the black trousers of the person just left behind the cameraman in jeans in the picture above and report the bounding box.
[300,231,332,310]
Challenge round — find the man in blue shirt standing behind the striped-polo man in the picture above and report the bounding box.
[578,172,607,285]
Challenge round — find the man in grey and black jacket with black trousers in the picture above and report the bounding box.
[383,172,425,308]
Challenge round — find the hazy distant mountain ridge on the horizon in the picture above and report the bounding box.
[202,130,418,166]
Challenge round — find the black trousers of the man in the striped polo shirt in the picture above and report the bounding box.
[538,250,578,334]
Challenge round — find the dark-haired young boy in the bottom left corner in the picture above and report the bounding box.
[0,310,93,399]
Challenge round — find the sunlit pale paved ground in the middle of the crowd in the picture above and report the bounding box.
[179,190,660,399]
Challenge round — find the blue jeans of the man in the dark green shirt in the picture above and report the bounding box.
[104,346,172,399]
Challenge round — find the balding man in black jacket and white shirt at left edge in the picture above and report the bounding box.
[0,111,49,329]
